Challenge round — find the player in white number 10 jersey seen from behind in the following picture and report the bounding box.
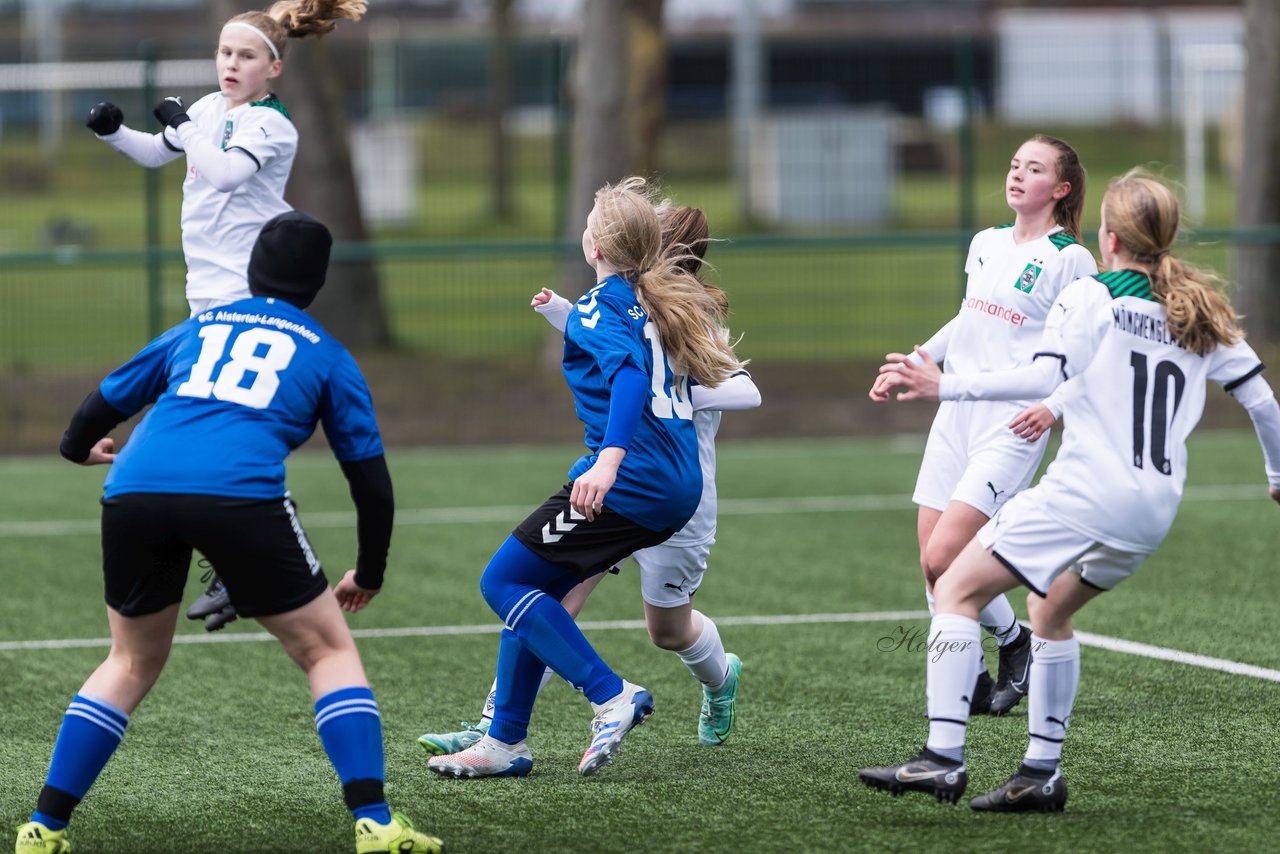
[859,170,1280,812]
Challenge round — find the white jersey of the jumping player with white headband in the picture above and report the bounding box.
[164,92,298,302]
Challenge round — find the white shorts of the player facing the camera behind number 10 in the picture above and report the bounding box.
[911,401,1048,516]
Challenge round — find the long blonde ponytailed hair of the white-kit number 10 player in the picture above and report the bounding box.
[1102,169,1244,356]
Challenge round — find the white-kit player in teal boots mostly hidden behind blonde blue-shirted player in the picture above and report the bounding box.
[419,207,760,777]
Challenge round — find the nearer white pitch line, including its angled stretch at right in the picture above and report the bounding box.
[0,611,1280,682]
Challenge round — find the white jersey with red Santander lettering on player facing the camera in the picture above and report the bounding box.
[943,225,1098,391]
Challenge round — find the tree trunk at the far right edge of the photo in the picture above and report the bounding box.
[1234,0,1280,341]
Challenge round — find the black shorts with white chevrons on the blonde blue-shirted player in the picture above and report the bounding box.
[512,484,676,579]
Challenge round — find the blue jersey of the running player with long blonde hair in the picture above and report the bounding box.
[563,275,703,531]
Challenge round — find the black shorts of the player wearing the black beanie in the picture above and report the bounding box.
[102,493,329,617]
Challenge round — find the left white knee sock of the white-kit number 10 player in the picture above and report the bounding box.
[925,613,982,755]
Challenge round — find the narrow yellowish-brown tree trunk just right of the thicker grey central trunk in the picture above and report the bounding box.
[627,0,667,175]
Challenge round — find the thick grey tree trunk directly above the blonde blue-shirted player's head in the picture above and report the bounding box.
[561,0,631,300]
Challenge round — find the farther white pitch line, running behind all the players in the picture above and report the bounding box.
[0,484,1267,539]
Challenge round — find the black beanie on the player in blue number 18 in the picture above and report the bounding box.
[248,210,333,309]
